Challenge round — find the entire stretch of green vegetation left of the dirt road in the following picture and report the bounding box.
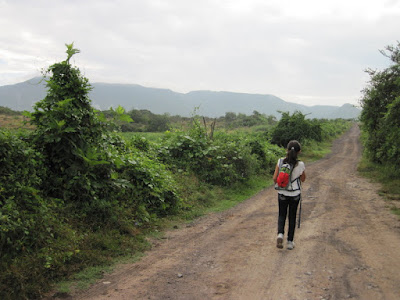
[0,44,352,299]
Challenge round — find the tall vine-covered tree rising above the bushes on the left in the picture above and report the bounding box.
[32,45,105,202]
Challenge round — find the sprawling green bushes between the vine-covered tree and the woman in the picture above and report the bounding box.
[159,118,279,185]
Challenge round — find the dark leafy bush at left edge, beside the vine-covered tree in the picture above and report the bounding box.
[0,131,47,261]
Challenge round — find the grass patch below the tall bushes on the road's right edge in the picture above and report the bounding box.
[358,155,400,218]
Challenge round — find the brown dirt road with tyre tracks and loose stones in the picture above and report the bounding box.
[73,126,400,300]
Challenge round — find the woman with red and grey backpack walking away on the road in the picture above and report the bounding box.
[273,140,306,250]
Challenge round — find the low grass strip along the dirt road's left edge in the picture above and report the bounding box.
[53,131,344,297]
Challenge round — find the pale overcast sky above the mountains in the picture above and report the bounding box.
[0,0,400,106]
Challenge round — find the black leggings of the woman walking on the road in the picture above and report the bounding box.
[278,194,300,241]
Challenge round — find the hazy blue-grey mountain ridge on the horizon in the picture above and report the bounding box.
[0,78,361,119]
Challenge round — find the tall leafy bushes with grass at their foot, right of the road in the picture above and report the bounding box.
[359,42,400,216]
